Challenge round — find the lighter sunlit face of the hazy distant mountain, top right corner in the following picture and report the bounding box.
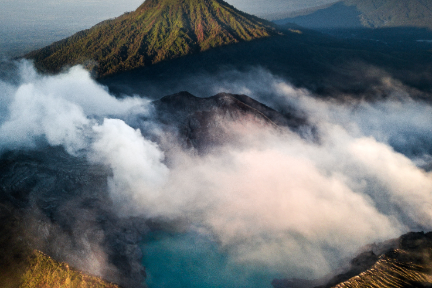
[344,0,432,29]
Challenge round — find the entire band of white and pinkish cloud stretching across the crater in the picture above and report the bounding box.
[0,62,432,278]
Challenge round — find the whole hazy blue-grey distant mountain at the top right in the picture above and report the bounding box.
[275,0,432,29]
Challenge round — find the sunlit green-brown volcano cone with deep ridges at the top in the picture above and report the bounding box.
[25,0,277,76]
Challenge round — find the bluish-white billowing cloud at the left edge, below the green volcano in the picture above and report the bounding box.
[0,61,148,154]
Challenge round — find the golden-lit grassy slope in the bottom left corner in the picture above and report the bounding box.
[0,203,119,288]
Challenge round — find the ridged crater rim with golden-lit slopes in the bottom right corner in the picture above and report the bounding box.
[272,232,432,288]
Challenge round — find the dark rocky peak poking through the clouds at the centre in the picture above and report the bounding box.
[153,92,313,151]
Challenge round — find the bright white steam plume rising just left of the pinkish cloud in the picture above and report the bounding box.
[90,119,169,216]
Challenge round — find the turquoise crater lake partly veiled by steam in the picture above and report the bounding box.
[143,232,281,288]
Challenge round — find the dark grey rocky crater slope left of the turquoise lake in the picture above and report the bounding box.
[0,147,148,287]
